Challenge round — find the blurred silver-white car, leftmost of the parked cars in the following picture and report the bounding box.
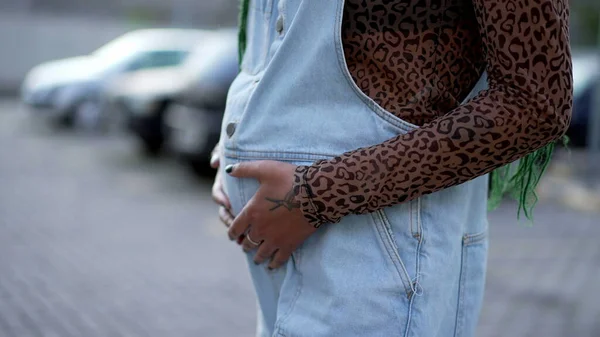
[21,29,204,126]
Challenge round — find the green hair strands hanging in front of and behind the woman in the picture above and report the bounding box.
[238,0,569,222]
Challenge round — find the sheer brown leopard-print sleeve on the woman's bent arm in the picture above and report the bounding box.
[295,0,572,227]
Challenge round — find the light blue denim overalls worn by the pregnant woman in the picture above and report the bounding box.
[220,0,488,337]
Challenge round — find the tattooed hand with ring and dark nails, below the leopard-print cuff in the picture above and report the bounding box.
[226,161,316,269]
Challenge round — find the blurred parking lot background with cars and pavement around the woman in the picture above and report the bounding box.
[0,0,600,337]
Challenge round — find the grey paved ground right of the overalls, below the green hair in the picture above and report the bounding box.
[477,201,600,337]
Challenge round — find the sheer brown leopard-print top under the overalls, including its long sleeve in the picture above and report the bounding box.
[295,0,573,227]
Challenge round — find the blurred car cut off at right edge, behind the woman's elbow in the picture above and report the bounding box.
[567,50,600,147]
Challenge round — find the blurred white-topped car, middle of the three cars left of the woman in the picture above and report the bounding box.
[108,29,237,155]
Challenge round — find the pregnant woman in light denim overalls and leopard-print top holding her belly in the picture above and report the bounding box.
[213,0,572,337]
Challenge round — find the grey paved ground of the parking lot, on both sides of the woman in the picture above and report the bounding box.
[0,101,600,337]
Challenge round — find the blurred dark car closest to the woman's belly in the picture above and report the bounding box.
[166,32,238,173]
